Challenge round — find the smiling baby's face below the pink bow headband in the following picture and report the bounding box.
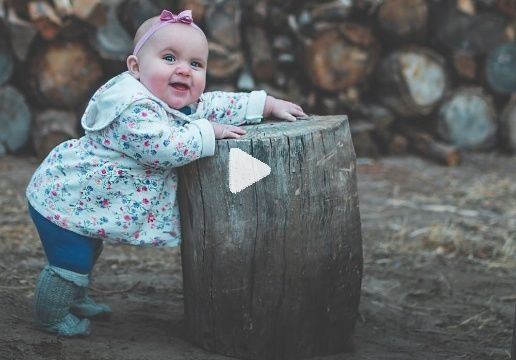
[137,24,208,109]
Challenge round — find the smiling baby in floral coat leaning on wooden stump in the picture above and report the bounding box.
[27,10,306,337]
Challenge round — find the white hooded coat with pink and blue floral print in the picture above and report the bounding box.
[26,72,266,247]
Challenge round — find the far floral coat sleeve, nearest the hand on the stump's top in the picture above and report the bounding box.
[202,90,267,125]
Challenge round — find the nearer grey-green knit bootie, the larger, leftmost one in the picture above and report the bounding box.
[34,266,90,337]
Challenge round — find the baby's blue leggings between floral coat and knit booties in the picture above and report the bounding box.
[29,204,102,274]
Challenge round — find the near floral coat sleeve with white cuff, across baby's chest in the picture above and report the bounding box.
[95,100,215,168]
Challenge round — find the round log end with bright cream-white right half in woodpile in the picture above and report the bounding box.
[376,46,448,117]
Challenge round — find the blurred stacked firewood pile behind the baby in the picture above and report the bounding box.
[0,0,516,165]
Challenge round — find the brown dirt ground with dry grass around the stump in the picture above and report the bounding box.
[0,153,516,360]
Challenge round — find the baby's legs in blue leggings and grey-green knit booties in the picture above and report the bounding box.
[29,206,111,336]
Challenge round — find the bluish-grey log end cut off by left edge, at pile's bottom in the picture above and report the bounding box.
[0,85,32,155]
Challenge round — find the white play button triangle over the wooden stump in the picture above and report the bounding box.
[229,148,271,194]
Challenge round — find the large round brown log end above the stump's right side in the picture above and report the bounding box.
[305,23,377,92]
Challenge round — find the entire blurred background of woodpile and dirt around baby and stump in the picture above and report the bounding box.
[0,0,516,360]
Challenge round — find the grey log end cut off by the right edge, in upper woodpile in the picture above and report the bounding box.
[485,41,516,94]
